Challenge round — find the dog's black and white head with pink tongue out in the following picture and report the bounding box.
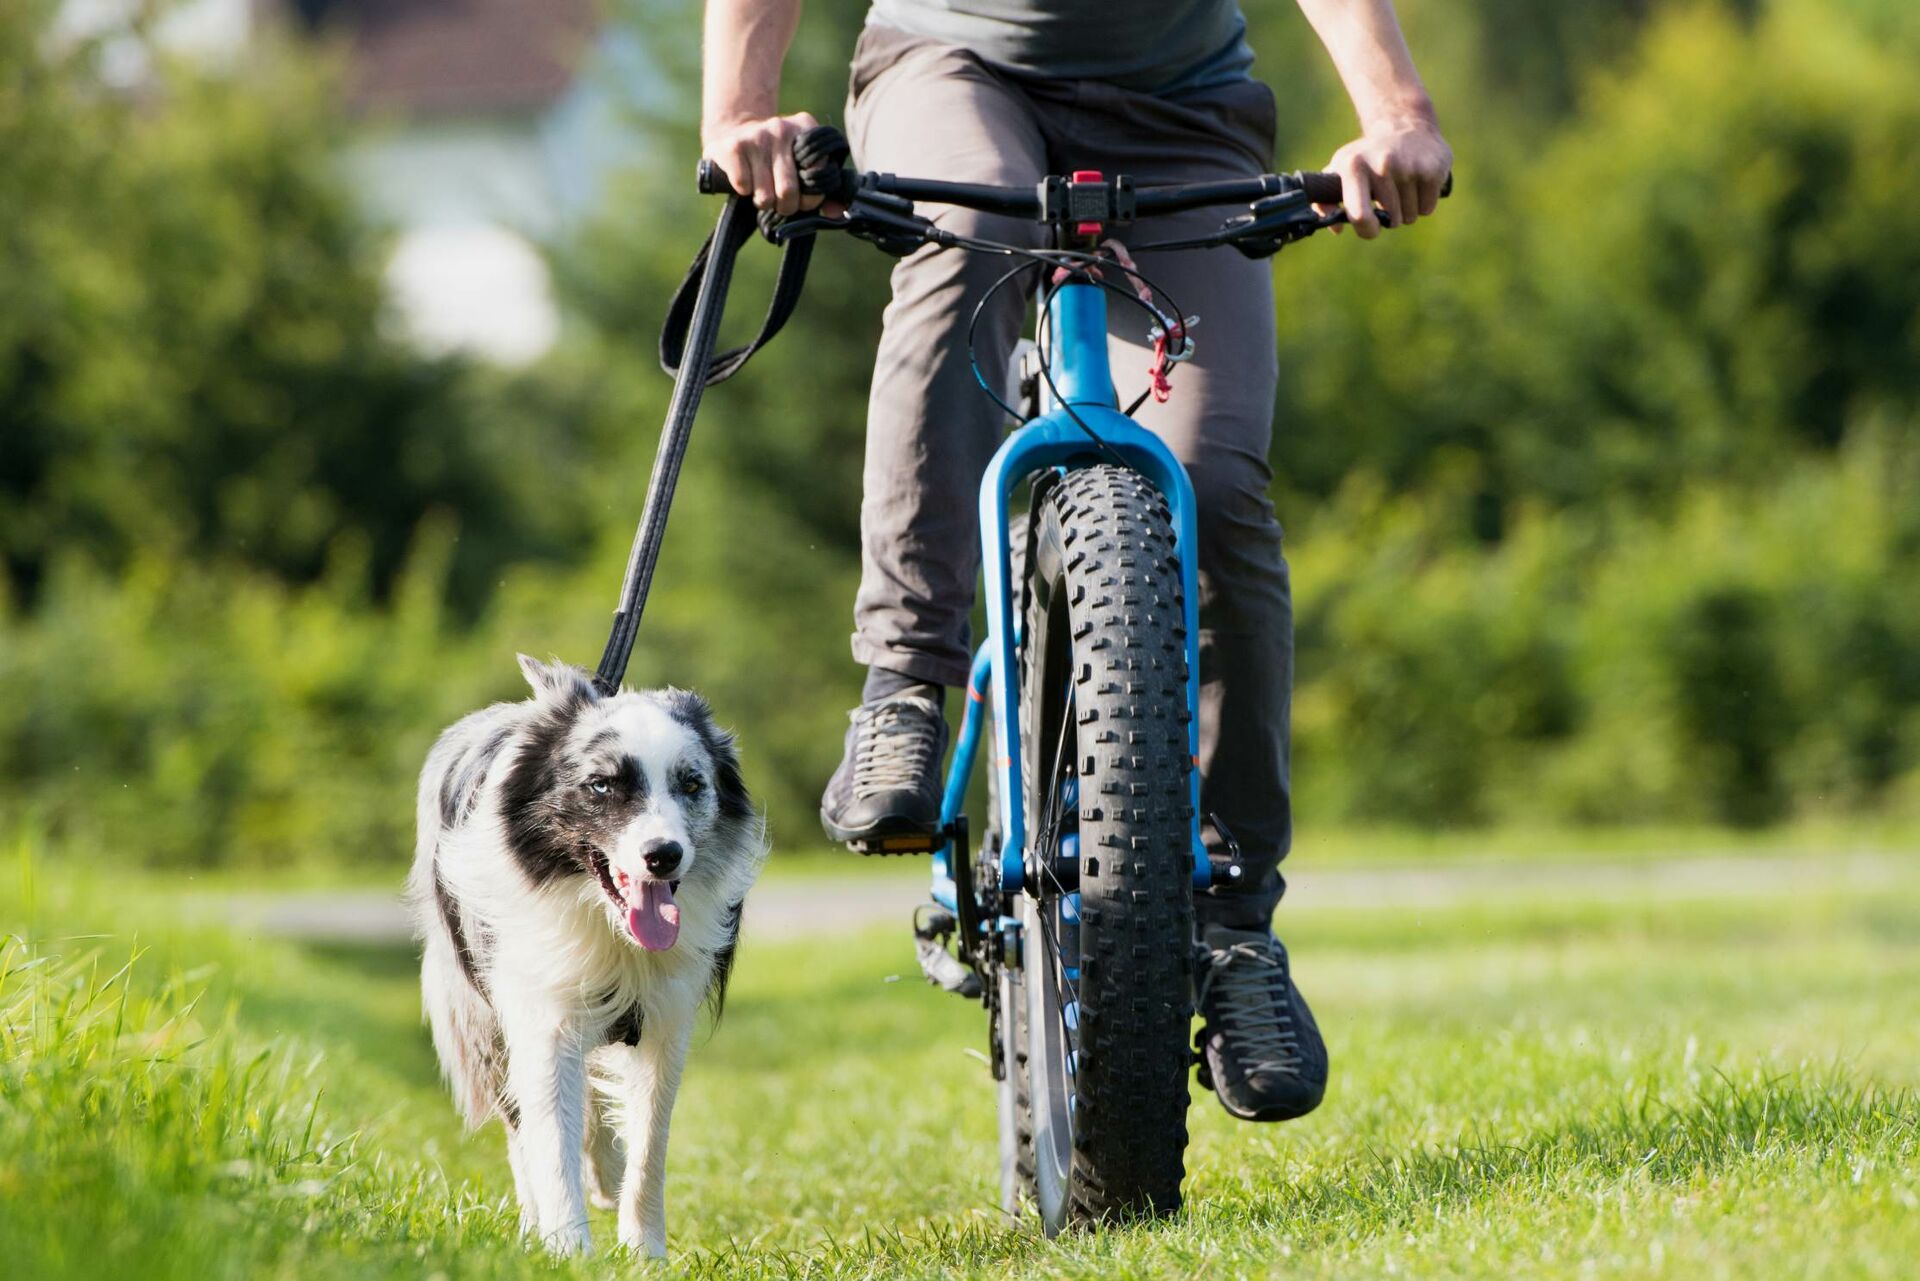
[501,655,756,951]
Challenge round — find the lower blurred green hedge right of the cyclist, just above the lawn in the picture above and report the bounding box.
[1294,430,1920,826]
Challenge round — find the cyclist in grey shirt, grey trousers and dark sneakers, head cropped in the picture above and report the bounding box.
[701,0,1452,1120]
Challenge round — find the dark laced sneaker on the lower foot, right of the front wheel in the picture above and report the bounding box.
[1196,926,1327,1122]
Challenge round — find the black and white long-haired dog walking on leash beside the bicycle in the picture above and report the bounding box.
[409,655,766,1256]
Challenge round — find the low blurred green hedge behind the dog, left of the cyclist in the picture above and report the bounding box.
[0,469,856,868]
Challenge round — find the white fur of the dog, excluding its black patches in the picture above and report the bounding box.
[409,661,766,1258]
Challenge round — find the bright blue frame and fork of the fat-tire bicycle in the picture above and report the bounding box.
[933,280,1212,908]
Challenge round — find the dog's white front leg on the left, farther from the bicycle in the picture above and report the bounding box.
[499,1001,589,1254]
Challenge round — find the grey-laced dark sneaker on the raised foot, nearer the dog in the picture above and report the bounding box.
[820,686,947,853]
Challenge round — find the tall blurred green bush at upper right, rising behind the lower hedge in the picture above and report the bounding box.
[1275,0,1920,514]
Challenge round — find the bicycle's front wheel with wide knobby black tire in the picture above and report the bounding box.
[1002,467,1192,1233]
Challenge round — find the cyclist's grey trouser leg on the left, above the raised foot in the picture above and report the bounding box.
[849,29,1044,686]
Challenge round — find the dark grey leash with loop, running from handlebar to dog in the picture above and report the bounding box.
[593,196,812,695]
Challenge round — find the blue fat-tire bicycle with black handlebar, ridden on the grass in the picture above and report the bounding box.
[679,129,1443,1235]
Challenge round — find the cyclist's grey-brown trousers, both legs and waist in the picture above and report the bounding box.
[847,27,1294,928]
